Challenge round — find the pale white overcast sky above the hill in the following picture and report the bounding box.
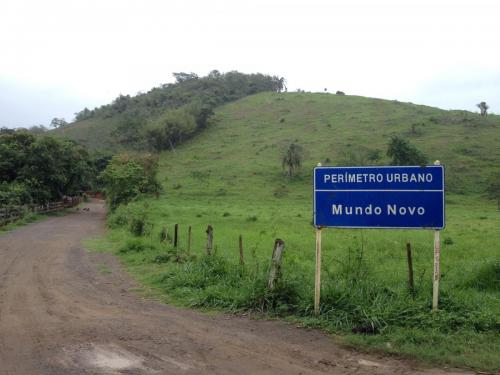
[0,0,500,127]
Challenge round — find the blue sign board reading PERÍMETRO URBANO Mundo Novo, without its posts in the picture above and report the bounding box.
[314,165,445,229]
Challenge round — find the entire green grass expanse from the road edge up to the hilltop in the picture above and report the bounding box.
[89,93,500,372]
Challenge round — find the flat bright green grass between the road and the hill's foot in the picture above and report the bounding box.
[88,196,500,372]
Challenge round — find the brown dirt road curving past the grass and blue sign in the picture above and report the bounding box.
[0,202,470,375]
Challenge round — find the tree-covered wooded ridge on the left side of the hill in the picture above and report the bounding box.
[61,70,286,151]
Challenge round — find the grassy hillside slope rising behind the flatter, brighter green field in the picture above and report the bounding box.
[164,93,500,194]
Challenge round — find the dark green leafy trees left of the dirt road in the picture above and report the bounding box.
[0,131,95,206]
